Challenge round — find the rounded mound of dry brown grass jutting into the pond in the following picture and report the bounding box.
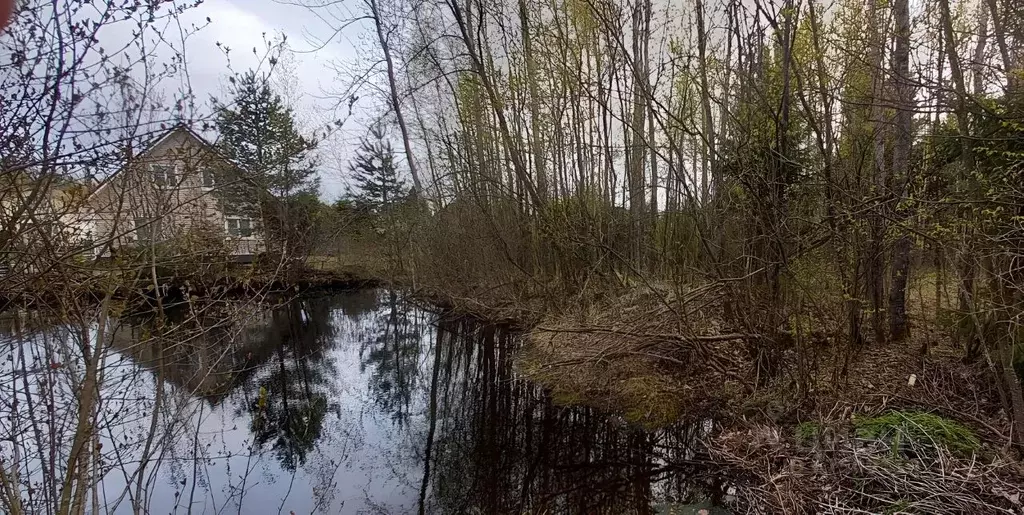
[520,289,749,427]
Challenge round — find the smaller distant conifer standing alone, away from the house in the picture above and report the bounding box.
[348,128,409,214]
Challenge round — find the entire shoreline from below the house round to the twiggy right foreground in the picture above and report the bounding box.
[4,268,1024,513]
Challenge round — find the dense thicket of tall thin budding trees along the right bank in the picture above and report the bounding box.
[323,0,1024,444]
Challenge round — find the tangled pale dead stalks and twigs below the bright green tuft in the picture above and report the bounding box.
[709,419,1024,514]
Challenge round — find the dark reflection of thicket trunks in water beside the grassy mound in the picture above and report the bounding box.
[420,323,722,513]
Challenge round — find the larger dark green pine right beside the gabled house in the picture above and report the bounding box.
[214,72,319,255]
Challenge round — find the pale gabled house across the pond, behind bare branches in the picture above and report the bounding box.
[79,125,265,261]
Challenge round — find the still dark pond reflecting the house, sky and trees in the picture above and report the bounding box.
[0,290,724,514]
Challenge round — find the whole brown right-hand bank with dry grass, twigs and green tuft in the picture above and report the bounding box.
[378,272,1024,513]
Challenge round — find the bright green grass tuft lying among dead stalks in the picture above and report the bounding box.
[853,411,981,456]
